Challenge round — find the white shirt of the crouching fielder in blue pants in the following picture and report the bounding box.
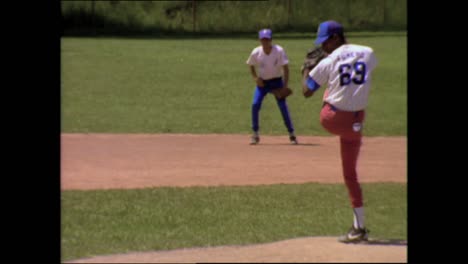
[246,44,289,80]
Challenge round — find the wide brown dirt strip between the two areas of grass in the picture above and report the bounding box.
[61,134,406,190]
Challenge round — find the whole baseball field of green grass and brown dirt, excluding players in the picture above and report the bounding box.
[61,32,407,263]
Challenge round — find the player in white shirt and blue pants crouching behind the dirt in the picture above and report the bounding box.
[246,29,297,145]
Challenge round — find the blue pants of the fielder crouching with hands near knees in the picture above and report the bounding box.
[252,78,294,133]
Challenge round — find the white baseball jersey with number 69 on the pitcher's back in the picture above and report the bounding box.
[309,44,377,111]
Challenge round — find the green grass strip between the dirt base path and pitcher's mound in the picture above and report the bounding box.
[61,183,407,260]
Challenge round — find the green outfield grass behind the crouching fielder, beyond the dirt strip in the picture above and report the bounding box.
[61,33,407,136]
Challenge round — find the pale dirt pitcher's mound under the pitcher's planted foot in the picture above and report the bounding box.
[68,237,407,263]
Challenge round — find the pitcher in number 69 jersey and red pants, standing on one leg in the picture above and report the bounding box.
[302,21,377,243]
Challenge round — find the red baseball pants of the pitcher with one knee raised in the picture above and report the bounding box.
[320,103,365,208]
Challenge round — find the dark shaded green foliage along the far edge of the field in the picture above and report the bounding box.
[61,0,407,36]
